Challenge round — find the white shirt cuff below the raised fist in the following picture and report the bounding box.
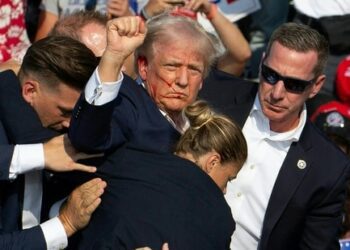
[84,68,124,106]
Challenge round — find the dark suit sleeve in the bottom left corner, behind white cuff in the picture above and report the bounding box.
[0,226,47,250]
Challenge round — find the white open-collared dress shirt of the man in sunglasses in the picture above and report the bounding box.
[225,94,306,250]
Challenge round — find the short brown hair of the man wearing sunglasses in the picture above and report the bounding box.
[266,23,329,77]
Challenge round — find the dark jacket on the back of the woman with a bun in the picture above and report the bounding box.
[79,148,234,250]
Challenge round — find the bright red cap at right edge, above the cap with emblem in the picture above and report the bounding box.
[335,56,350,105]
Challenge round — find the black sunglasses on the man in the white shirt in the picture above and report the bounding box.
[261,63,315,93]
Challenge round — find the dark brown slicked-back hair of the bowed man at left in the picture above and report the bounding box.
[19,36,98,90]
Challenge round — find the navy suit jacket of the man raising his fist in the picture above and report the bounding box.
[69,73,180,152]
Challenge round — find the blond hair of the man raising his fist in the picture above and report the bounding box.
[135,13,218,76]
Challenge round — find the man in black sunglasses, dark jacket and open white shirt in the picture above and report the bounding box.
[200,23,349,250]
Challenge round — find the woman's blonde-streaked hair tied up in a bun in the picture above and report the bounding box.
[176,100,248,165]
